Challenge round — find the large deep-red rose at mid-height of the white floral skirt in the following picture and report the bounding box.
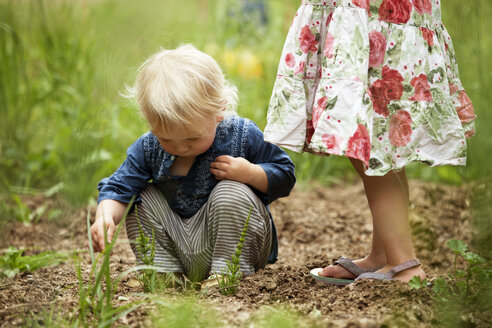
[369,66,404,117]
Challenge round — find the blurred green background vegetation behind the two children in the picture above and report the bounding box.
[0,0,492,195]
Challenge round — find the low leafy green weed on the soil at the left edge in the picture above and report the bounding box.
[0,246,73,278]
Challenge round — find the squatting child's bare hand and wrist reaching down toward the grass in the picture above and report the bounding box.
[91,199,127,252]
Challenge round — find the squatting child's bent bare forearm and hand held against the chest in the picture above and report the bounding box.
[210,155,268,193]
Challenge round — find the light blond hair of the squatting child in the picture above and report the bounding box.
[126,45,237,130]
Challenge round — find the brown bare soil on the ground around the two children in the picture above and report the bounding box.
[0,181,471,327]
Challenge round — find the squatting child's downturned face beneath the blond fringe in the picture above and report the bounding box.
[152,116,222,157]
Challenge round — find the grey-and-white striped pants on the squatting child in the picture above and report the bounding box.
[126,180,272,281]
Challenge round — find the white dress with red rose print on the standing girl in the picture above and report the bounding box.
[264,0,475,175]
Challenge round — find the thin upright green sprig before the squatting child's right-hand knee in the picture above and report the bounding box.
[218,206,253,295]
